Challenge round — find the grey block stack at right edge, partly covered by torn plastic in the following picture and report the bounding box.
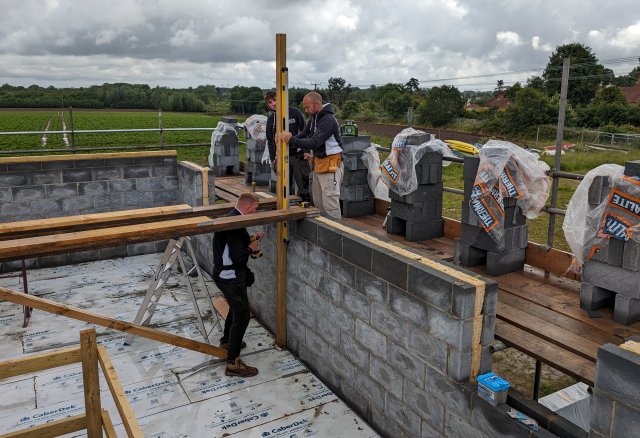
[580,160,640,325]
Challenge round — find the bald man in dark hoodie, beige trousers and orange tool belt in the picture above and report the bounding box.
[280,91,344,219]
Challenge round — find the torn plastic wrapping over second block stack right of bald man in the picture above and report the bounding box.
[381,128,455,195]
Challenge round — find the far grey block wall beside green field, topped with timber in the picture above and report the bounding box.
[0,151,215,273]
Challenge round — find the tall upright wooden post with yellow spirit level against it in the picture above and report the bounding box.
[276,33,289,348]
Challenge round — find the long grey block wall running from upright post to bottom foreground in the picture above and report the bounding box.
[232,219,553,438]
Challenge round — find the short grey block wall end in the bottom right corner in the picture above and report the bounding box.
[589,339,640,438]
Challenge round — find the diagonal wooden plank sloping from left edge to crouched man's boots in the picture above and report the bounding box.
[0,287,227,359]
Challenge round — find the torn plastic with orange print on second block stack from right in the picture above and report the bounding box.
[469,140,551,242]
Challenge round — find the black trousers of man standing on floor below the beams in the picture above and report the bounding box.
[215,280,250,363]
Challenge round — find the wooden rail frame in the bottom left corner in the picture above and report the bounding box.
[0,329,144,438]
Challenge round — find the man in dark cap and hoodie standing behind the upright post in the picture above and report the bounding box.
[264,91,311,202]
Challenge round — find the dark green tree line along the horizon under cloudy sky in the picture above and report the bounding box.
[0,43,640,136]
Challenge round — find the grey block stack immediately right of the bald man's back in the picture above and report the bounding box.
[340,135,375,217]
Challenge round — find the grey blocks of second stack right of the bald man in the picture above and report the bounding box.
[387,134,444,242]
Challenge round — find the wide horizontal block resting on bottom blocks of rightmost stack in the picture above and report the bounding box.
[582,260,640,299]
